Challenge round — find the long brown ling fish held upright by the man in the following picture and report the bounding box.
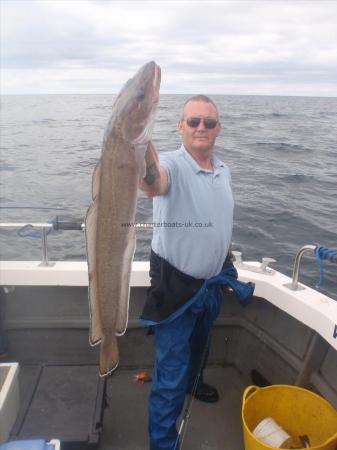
[85,62,160,376]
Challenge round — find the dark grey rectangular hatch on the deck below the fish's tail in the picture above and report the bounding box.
[10,365,106,450]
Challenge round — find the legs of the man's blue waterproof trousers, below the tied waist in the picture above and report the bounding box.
[149,309,213,450]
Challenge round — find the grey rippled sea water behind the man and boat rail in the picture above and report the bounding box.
[0,95,337,299]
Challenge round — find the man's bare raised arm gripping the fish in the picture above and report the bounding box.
[139,142,168,197]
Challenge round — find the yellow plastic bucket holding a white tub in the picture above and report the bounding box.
[242,384,337,450]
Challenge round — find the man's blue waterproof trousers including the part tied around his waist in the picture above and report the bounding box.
[143,268,254,450]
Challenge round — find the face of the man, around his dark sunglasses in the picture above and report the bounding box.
[178,101,221,153]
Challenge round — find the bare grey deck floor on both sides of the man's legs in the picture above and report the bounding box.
[99,367,246,450]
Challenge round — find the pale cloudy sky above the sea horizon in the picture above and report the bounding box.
[0,0,337,97]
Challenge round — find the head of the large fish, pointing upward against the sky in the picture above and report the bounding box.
[115,61,161,145]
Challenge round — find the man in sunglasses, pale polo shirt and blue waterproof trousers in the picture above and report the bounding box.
[140,95,253,450]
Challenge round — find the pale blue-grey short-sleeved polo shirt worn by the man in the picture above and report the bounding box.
[152,146,234,279]
